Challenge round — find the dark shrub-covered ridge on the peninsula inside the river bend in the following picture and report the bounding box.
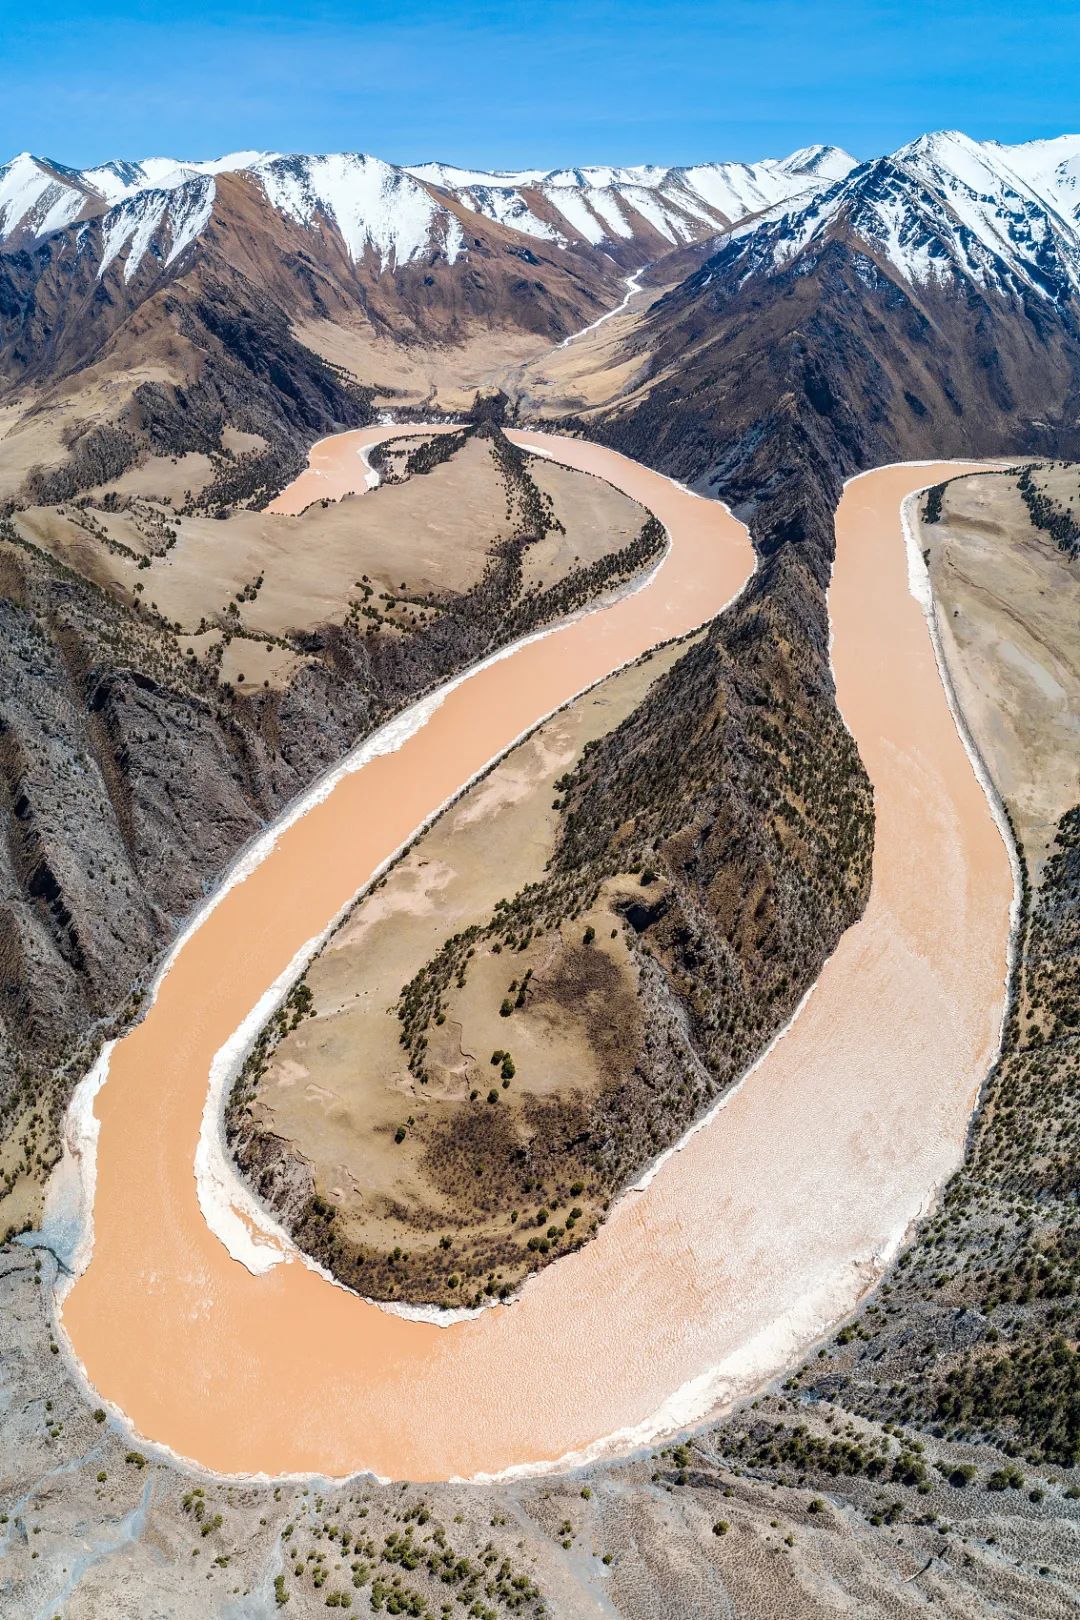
[230,476,871,1304]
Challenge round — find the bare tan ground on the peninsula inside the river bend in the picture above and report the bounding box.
[241,631,687,1254]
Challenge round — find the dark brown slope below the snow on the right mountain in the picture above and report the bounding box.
[595,241,1080,491]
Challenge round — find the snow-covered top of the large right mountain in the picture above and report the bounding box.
[724,131,1080,301]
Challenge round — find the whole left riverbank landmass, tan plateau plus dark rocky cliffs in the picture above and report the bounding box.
[0,428,661,1226]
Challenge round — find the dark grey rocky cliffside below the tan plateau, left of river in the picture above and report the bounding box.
[0,426,657,1225]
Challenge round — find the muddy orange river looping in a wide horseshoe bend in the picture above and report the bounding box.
[52,428,1012,1479]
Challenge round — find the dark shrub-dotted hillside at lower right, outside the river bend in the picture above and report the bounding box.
[773,807,1080,1482]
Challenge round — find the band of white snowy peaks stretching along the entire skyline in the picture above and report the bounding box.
[12,130,1080,300]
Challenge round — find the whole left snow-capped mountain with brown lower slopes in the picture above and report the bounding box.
[0,152,641,417]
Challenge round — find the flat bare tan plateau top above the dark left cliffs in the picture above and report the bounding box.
[15,439,644,657]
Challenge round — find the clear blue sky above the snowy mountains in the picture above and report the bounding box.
[0,0,1080,167]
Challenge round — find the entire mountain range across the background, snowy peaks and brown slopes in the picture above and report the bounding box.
[0,131,1080,515]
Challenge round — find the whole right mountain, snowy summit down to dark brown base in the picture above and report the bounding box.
[591,131,1080,505]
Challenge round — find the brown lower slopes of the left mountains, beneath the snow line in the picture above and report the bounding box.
[0,175,619,497]
